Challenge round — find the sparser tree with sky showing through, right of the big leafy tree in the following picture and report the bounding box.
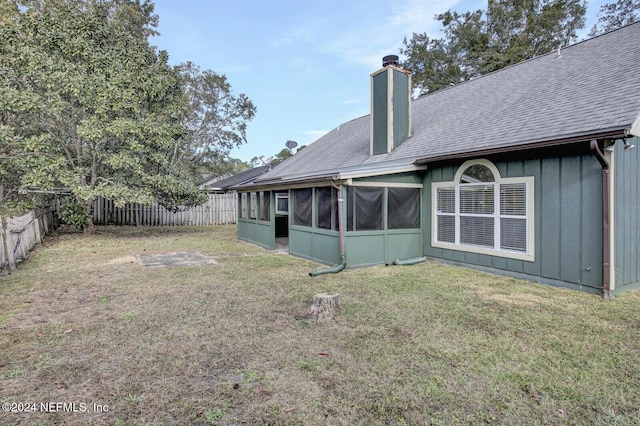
[171,62,256,180]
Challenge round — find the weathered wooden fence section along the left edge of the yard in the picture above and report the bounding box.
[0,205,59,271]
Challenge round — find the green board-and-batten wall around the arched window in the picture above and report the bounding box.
[423,155,602,292]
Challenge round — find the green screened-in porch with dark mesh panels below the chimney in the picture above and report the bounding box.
[238,174,423,267]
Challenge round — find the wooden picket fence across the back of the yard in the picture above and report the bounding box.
[93,192,238,226]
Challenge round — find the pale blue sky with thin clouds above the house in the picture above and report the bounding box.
[151,0,606,162]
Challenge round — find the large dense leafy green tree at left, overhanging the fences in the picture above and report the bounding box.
[0,0,202,232]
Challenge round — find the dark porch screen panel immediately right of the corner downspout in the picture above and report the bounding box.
[347,186,384,231]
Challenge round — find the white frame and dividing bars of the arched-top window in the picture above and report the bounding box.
[431,159,535,262]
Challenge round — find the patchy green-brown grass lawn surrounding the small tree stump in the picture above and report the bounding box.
[0,226,640,425]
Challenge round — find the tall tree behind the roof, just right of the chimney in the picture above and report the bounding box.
[400,0,586,95]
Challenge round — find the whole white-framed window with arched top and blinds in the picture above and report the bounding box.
[432,160,533,261]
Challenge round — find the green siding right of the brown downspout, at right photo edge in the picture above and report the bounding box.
[613,138,640,293]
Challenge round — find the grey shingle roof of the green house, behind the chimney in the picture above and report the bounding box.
[256,23,640,183]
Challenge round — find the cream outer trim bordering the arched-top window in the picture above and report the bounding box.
[431,159,535,262]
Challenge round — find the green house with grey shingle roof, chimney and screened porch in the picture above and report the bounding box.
[238,23,640,298]
